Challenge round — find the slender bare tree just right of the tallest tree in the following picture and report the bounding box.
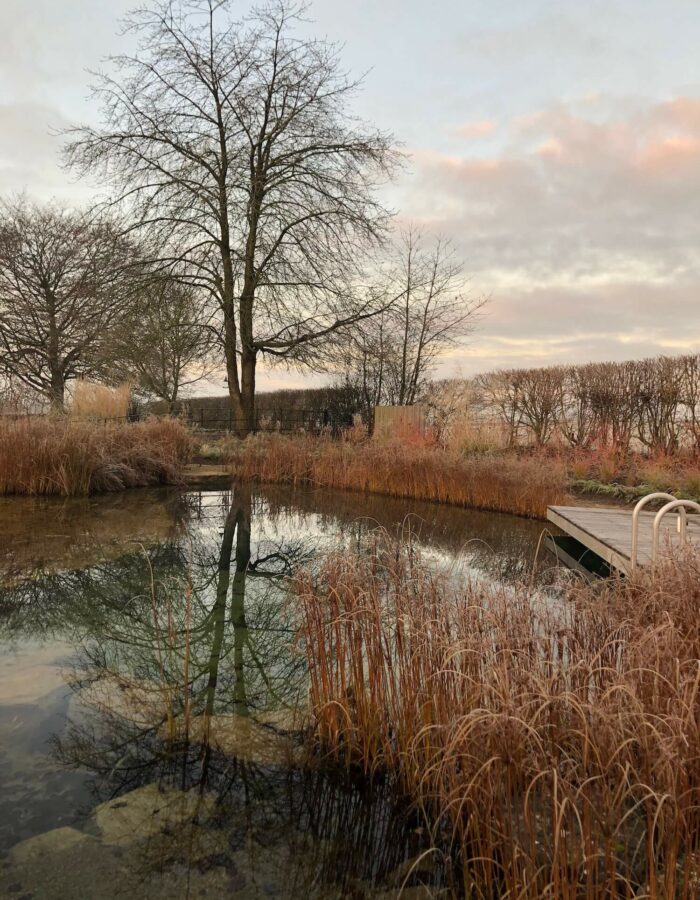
[345,229,486,413]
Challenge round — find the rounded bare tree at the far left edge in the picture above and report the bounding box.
[0,197,131,407]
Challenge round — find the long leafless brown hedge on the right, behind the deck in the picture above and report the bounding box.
[452,354,700,454]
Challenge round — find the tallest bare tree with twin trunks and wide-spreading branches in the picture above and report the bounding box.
[68,0,404,433]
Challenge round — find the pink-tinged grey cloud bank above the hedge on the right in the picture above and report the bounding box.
[401,96,700,371]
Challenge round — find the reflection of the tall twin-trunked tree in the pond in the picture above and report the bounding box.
[44,491,305,800]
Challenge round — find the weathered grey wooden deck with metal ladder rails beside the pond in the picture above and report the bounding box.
[547,506,700,572]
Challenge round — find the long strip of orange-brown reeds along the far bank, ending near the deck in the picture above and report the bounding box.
[232,435,566,518]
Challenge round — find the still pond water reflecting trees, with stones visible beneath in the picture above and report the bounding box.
[0,486,546,900]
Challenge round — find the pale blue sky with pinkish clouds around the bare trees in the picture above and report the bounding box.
[0,0,700,387]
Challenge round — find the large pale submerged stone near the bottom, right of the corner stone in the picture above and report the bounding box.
[95,784,216,845]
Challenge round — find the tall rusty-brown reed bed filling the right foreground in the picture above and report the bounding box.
[296,539,700,900]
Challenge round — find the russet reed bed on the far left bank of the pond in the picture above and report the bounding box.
[0,416,192,496]
